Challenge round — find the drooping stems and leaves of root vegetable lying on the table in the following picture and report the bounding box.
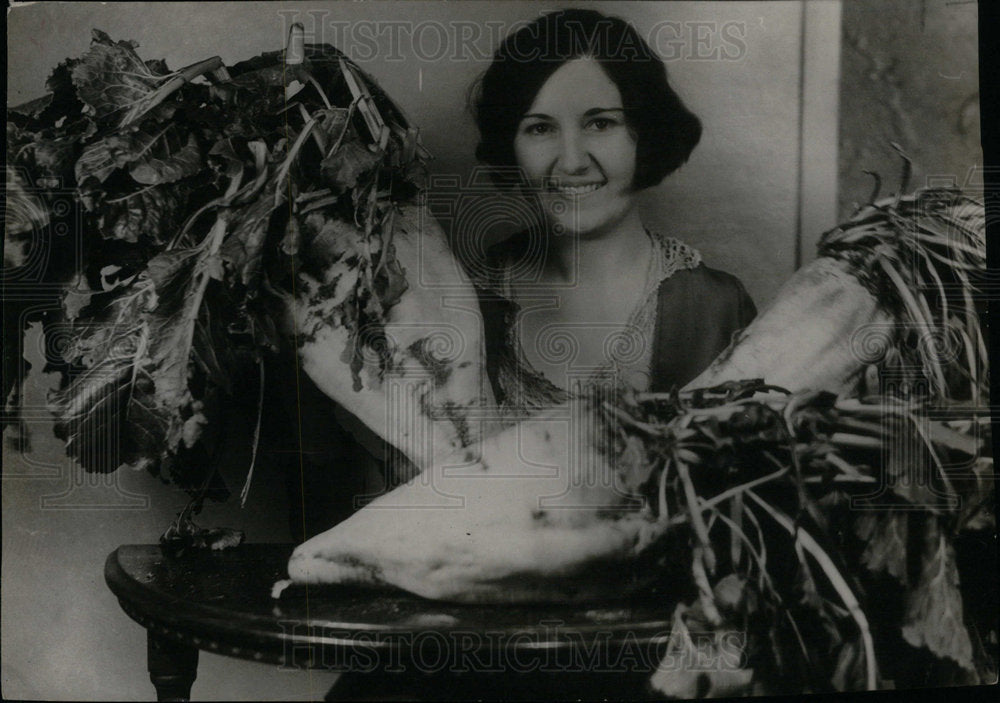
[608,383,993,697]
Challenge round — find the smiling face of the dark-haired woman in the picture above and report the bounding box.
[514,58,636,236]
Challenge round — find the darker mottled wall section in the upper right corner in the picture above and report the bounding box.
[838,0,983,217]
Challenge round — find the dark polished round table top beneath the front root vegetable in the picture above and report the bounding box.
[105,544,673,670]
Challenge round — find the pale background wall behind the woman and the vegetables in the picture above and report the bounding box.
[0,0,978,700]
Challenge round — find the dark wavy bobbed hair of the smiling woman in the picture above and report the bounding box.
[472,10,701,190]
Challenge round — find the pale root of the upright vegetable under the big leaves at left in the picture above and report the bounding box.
[288,199,493,468]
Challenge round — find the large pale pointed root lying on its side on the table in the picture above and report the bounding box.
[288,398,660,602]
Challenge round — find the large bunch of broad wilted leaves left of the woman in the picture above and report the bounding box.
[6,30,426,500]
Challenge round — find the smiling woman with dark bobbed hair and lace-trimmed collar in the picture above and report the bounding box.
[475,10,755,415]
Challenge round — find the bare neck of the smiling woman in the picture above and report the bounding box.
[545,208,651,287]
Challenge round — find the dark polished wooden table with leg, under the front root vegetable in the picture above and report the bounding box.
[104,544,672,701]
